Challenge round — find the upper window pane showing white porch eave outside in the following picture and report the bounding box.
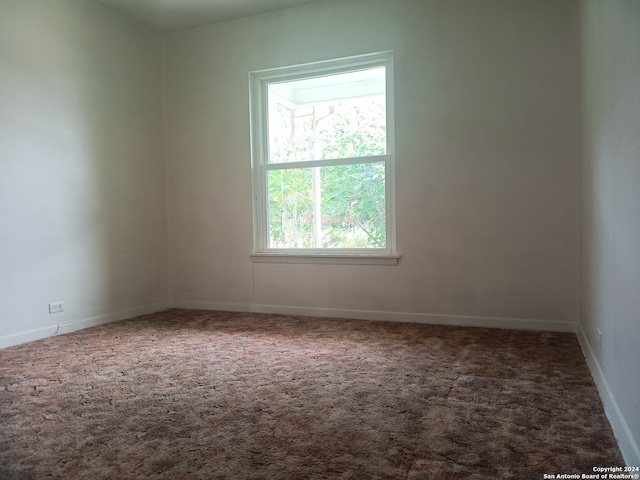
[267,67,387,163]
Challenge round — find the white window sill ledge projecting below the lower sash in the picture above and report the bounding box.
[251,253,400,266]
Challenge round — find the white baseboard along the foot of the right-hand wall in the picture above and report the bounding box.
[577,324,640,467]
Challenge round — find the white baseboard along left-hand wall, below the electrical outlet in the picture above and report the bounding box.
[0,302,169,349]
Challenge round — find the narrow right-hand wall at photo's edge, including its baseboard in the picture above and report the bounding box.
[579,0,640,465]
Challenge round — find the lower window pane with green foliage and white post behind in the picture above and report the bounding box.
[267,162,387,248]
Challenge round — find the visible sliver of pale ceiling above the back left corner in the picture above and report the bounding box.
[94,0,319,33]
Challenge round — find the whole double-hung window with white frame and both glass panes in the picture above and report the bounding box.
[250,53,397,266]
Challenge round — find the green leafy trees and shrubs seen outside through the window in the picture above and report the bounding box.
[268,97,387,248]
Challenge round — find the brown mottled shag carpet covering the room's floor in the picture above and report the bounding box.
[0,310,623,480]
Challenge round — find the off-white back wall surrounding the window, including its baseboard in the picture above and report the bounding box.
[164,0,580,330]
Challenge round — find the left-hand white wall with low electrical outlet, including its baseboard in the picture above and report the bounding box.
[0,0,167,346]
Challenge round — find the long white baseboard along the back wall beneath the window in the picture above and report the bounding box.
[171,300,576,333]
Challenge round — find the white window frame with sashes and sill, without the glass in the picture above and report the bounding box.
[249,52,400,265]
